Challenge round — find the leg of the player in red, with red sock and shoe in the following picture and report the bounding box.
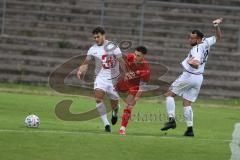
[119,94,136,135]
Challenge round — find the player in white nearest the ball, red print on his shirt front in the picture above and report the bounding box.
[77,27,125,132]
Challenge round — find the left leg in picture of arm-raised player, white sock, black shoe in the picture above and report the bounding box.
[161,90,176,131]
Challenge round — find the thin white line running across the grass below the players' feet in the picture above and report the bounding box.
[0,128,236,143]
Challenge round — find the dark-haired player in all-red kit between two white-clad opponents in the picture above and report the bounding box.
[116,46,150,135]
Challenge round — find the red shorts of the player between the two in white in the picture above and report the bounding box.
[116,80,139,96]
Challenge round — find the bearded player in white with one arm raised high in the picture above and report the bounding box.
[161,18,222,137]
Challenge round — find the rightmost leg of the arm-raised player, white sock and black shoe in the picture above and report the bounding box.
[183,99,194,137]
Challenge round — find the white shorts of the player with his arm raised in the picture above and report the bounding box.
[169,72,203,102]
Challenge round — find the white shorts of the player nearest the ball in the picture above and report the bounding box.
[94,77,119,100]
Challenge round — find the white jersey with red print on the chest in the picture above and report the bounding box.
[87,40,122,80]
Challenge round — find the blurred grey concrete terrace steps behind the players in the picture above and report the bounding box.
[0,0,240,98]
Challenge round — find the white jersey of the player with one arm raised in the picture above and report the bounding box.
[181,36,216,74]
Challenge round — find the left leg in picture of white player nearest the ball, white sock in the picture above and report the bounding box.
[94,89,111,132]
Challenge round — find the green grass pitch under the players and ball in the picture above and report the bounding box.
[0,84,240,160]
